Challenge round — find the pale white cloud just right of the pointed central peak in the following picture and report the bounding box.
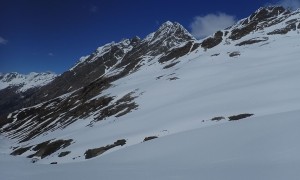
[190,13,236,38]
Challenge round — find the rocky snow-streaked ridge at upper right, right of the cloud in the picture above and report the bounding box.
[201,6,300,49]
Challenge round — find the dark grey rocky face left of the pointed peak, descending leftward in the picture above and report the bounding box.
[31,38,139,102]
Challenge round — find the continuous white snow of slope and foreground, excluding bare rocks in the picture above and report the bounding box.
[0,18,300,180]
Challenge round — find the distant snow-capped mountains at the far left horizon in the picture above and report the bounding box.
[0,72,56,92]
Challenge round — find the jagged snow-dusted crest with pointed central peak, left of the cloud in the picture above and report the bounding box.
[70,21,196,71]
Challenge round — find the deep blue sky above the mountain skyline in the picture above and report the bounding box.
[0,0,299,73]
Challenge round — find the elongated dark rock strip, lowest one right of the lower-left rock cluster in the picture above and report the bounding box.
[84,139,126,159]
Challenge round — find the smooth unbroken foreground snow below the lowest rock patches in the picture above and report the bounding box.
[0,110,300,180]
